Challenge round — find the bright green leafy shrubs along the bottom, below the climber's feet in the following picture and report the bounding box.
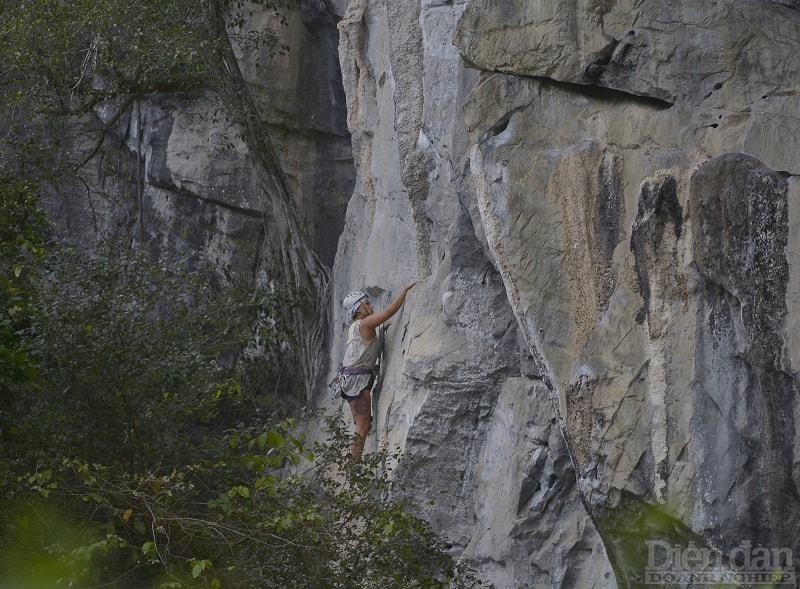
[0,421,466,589]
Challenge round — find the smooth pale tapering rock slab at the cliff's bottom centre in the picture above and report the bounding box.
[464,378,613,588]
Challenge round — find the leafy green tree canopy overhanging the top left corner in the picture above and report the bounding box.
[0,0,296,114]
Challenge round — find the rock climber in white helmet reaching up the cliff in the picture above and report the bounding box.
[340,280,419,460]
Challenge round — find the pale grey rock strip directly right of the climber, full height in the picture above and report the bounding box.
[331,0,624,587]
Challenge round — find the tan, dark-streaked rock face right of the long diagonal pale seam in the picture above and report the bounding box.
[446,2,800,586]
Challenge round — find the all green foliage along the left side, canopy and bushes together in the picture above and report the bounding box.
[0,0,466,589]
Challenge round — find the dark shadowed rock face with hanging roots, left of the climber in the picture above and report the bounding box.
[47,0,354,400]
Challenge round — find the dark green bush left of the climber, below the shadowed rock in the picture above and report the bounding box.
[6,243,292,472]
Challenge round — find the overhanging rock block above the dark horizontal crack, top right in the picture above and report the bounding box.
[456,0,800,110]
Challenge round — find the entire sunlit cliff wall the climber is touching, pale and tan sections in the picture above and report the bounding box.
[332,0,800,588]
